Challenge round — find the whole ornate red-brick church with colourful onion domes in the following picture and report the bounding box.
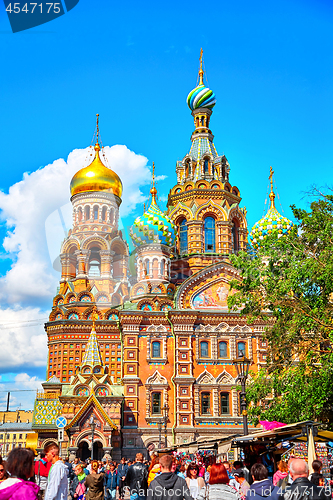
[33,52,291,460]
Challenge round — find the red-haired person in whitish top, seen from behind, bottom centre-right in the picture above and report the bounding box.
[196,464,241,500]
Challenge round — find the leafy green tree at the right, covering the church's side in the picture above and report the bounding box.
[228,193,333,425]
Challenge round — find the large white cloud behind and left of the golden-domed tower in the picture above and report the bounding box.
[0,145,151,372]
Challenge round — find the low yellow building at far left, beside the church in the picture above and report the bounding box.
[0,421,38,458]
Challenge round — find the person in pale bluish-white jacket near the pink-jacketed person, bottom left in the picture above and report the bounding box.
[44,443,68,500]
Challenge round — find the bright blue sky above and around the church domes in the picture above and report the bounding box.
[0,0,333,404]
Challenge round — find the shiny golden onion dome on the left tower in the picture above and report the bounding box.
[70,142,123,198]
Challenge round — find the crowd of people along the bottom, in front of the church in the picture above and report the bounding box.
[0,444,332,500]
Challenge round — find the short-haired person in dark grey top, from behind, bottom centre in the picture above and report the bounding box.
[147,455,193,500]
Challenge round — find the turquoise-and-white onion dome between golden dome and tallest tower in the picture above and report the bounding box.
[130,163,177,247]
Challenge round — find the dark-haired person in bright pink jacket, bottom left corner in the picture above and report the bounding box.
[0,448,39,500]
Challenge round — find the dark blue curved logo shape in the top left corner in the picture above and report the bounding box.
[3,0,79,33]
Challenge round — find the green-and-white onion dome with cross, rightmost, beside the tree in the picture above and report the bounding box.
[250,167,293,249]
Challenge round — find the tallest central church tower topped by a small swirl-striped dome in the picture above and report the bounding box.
[168,49,248,282]
